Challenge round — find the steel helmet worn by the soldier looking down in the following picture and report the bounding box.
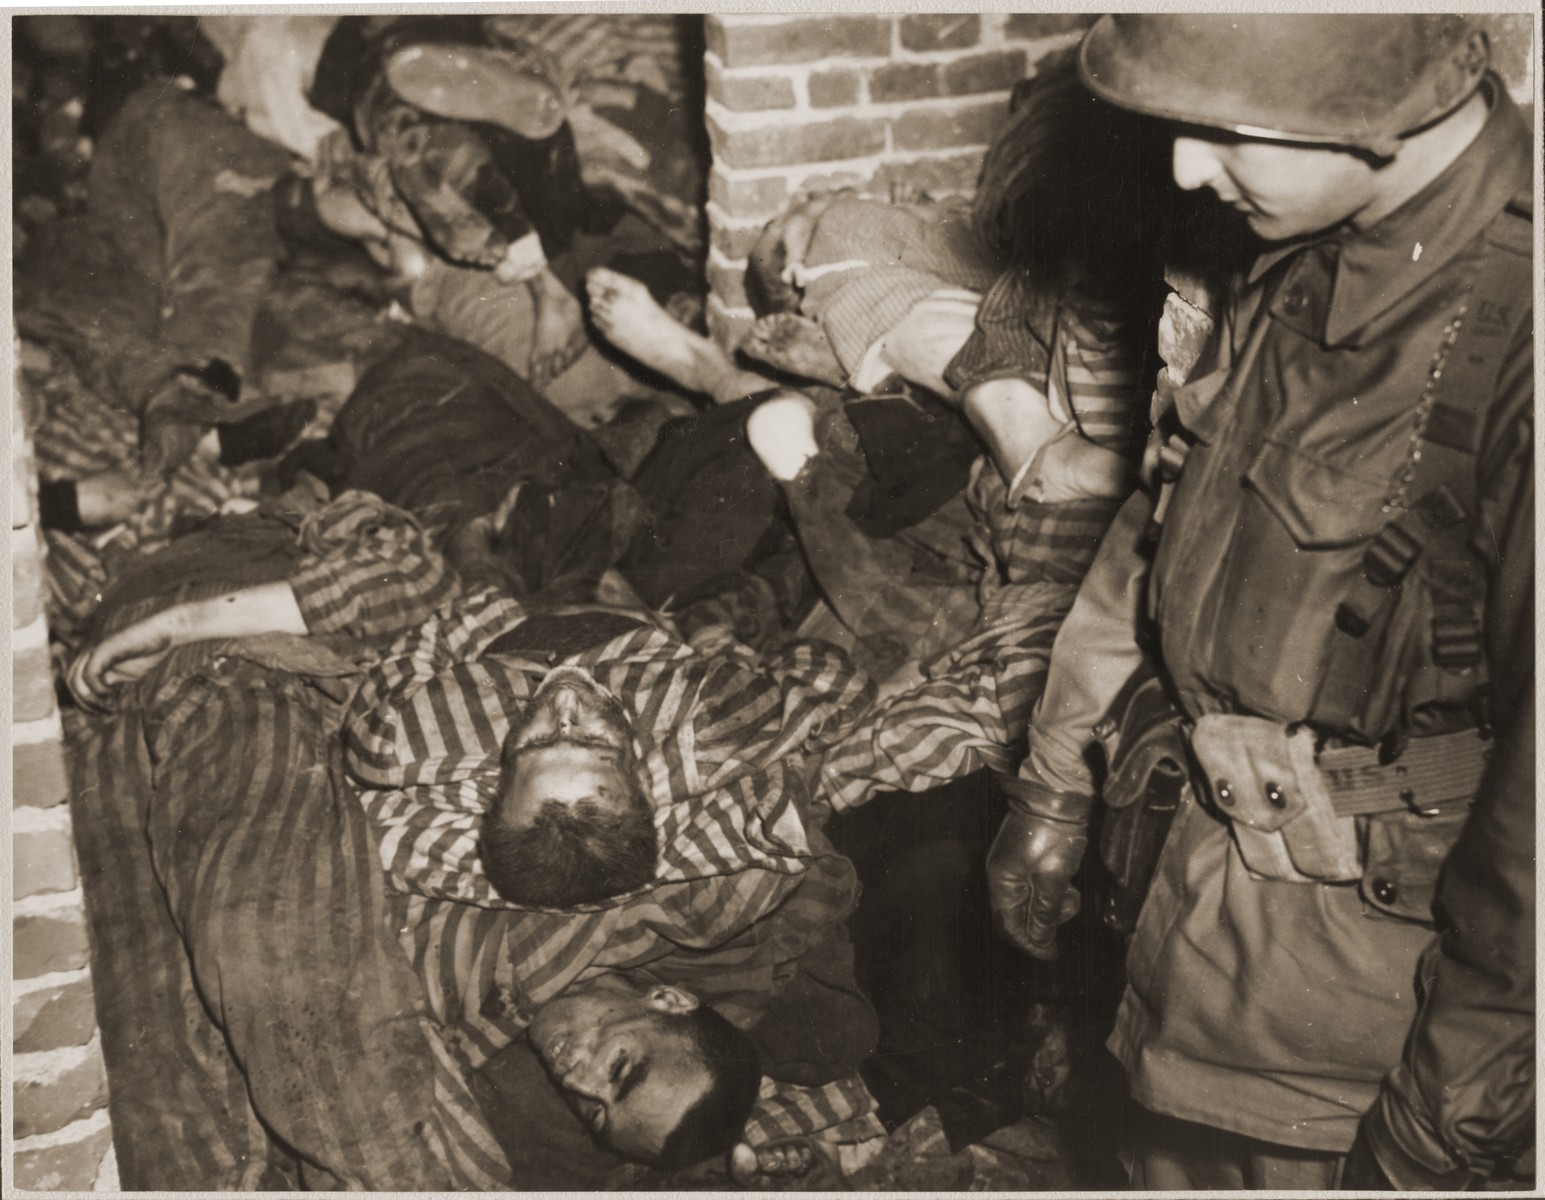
[1078,12,1491,154]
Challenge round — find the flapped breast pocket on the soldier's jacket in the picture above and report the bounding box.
[1245,442,1391,550]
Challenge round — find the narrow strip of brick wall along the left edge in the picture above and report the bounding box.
[6,349,117,1191]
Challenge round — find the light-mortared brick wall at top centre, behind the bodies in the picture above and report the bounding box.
[705,12,1092,346]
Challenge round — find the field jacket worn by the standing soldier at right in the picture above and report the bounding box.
[1026,77,1534,1186]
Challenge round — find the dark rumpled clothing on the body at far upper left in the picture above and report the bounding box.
[15,80,289,469]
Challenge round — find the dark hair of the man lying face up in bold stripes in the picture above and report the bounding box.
[477,785,660,908]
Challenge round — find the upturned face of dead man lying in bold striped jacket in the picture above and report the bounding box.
[499,667,635,825]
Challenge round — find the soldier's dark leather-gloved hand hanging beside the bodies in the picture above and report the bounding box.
[987,778,1094,961]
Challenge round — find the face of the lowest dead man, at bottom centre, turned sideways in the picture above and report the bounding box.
[528,975,712,1161]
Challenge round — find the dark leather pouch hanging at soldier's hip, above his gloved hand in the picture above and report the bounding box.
[1095,675,1191,934]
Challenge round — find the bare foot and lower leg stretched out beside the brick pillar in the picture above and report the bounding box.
[586,267,768,405]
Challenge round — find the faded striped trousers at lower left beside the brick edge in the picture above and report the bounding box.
[70,658,508,1191]
